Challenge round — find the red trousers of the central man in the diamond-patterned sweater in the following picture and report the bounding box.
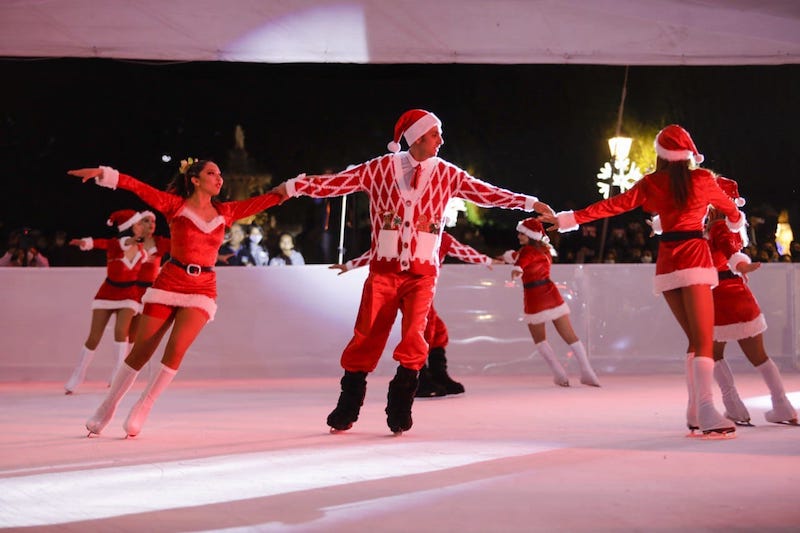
[341,272,436,372]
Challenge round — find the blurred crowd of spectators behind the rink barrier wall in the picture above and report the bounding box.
[0,207,800,267]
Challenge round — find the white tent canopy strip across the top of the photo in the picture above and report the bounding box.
[0,0,800,65]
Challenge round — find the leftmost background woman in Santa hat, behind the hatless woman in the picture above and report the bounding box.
[64,209,147,394]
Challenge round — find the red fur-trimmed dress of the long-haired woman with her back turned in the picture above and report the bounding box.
[558,168,745,294]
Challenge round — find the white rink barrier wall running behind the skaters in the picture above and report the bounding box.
[0,263,800,382]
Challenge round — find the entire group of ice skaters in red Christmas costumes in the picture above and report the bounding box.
[65,109,797,438]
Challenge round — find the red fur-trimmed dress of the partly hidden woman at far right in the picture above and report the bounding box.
[708,220,767,342]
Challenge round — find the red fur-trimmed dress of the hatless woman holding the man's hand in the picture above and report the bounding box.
[96,167,281,320]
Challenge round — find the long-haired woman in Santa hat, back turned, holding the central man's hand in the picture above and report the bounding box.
[540,124,745,437]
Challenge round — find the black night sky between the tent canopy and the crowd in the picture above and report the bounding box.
[0,59,800,243]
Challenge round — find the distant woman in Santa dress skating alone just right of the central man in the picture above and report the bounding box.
[503,218,600,387]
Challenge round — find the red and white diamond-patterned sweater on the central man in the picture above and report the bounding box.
[286,152,537,275]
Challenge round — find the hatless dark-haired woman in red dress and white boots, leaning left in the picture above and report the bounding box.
[69,160,280,436]
